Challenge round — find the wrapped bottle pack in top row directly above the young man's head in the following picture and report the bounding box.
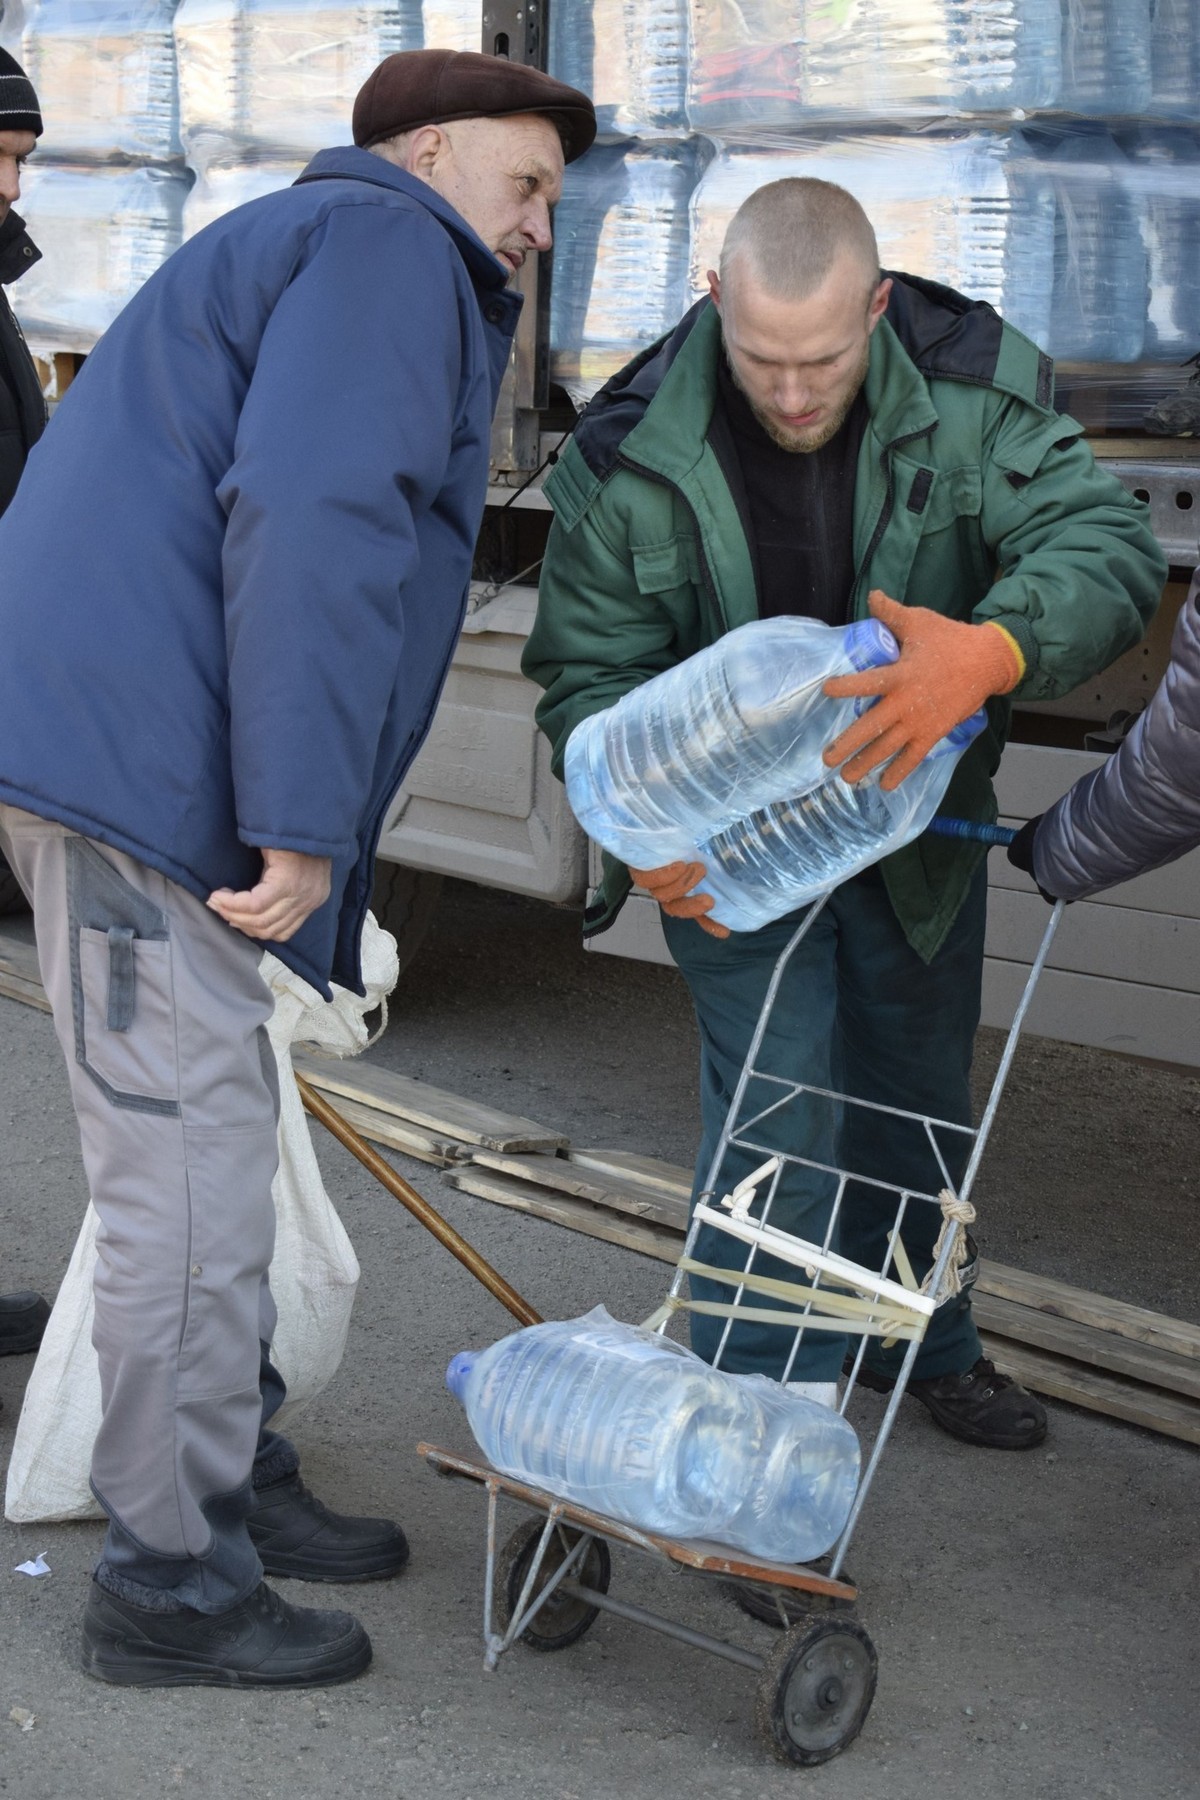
[687,0,1063,140]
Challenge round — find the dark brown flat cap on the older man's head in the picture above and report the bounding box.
[354,50,596,162]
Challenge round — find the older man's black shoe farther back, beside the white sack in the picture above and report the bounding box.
[246,1474,408,1580]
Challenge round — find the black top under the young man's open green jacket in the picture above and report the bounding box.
[709,356,867,625]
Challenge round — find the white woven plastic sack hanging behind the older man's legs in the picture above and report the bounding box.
[4,914,399,1525]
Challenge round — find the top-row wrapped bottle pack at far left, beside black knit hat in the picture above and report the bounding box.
[18,0,180,162]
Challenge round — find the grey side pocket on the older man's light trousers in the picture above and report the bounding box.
[65,837,180,1116]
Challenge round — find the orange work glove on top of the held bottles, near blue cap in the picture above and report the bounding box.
[824,587,1025,790]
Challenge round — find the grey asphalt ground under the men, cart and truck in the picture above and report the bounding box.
[0,884,1200,1800]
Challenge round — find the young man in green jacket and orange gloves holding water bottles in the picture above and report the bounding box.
[525,180,1166,1476]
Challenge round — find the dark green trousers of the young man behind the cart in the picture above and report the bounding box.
[662,868,988,1381]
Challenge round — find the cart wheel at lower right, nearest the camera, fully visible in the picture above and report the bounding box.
[754,1613,880,1766]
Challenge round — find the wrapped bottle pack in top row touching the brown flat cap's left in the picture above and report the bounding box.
[175,0,423,169]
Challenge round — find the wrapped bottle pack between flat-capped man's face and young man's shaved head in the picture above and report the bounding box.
[551,142,698,405]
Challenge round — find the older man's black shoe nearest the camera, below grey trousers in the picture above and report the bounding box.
[81,1580,371,1687]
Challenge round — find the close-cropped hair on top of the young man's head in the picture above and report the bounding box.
[720,176,880,316]
